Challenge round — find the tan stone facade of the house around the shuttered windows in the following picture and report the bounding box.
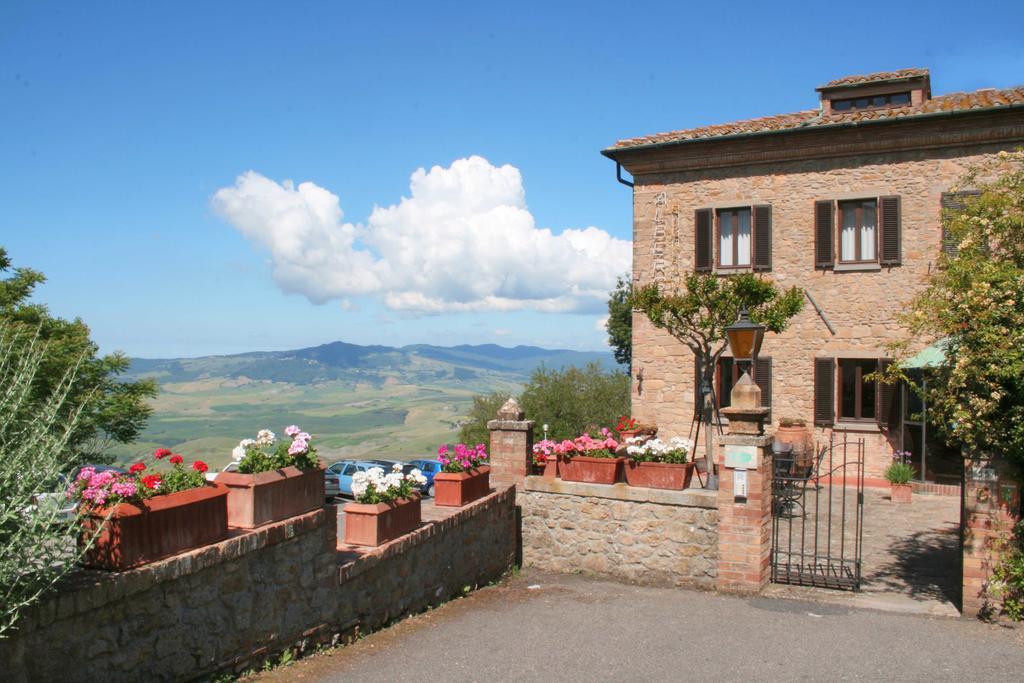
[632,144,1013,478]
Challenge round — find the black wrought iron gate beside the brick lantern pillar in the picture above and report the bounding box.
[771,437,864,591]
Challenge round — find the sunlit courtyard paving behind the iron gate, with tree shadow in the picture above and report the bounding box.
[767,488,961,616]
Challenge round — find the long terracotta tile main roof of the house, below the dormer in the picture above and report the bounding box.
[609,84,1024,152]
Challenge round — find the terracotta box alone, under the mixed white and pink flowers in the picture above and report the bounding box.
[214,467,325,528]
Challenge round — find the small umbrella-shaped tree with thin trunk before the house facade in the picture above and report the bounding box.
[633,273,804,481]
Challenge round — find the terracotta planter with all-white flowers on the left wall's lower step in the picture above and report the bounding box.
[344,463,425,546]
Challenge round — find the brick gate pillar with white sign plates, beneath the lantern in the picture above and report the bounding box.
[716,408,772,593]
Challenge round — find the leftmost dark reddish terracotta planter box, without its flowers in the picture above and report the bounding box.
[82,483,227,571]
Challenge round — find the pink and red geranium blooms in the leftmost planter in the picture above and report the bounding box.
[68,449,209,507]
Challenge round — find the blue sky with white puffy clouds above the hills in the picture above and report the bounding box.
[0,0,1024,356]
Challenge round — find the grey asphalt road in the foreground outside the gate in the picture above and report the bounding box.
[249,571,1024,683]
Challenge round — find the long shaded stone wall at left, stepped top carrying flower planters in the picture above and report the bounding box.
[0,488,516,681]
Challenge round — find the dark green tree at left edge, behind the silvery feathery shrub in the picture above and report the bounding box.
[0,248,157,463]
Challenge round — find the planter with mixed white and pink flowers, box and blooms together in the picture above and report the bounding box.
[214,425,325,528]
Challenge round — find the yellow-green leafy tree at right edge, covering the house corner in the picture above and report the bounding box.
[889,150,1024,466]
